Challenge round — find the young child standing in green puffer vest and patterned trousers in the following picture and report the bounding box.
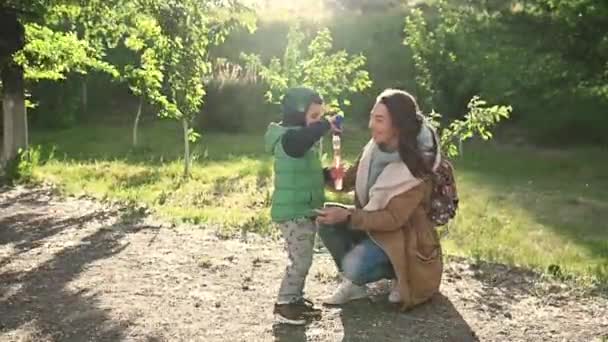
[264,87,338,325]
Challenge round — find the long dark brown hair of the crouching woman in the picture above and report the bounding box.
[376,89,430,178]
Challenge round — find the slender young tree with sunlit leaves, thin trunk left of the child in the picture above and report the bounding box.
[151,0,255,177]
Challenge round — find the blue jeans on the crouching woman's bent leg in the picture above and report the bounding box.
[318,224,395,285]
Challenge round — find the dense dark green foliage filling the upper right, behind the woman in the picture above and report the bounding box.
[404,0,608,144]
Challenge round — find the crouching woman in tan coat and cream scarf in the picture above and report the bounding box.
[317,89,443,309]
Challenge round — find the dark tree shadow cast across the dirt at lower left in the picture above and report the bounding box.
[0,188,159,341]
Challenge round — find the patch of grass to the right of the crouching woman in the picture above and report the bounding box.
[446,145,608,283]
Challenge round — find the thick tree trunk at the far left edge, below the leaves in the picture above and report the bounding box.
[1,64,28,166]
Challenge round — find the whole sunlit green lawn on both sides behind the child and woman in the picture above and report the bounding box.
[27,122,608,284]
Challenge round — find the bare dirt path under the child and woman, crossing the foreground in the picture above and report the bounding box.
[0,188,608,342]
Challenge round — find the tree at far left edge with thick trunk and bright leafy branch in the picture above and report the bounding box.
[0,0,115,166]
